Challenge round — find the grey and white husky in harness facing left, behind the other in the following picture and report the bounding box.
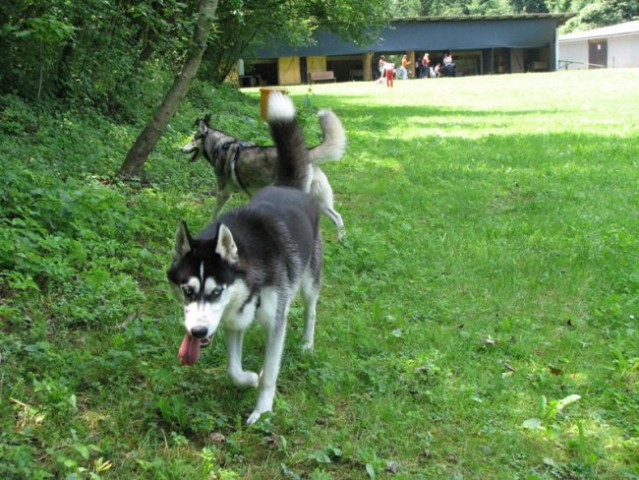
[182,107,346,238]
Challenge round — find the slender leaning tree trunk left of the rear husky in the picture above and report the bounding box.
[120,0,217,176]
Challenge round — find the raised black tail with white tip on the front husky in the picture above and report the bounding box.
[268,92,312,191]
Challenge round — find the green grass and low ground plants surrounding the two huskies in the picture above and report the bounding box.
[0,70,639,480]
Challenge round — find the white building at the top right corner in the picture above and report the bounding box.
[558,21,639,69]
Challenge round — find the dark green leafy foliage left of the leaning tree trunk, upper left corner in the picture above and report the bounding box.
[0,0,192,109]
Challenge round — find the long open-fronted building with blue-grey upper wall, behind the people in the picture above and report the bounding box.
[243,14,573,86]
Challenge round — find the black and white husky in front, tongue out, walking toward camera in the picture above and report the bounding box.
[168,93,322,424]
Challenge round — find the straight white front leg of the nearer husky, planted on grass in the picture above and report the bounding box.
[246,309,288,425]
